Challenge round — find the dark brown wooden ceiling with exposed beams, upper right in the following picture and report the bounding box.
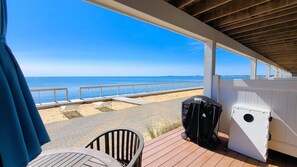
[165,0,297,74]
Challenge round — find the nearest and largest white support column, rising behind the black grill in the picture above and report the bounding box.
[203,41,216,98]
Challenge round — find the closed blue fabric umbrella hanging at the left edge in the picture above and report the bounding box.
[0,0,50,167]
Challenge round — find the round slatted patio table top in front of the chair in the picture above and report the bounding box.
[28,147,121,167]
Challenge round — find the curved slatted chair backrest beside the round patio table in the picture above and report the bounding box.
[85,129,144,167]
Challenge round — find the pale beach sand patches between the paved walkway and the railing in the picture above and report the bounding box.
[39,89,203,124]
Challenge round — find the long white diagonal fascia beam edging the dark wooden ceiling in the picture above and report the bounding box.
[86,0,287,71]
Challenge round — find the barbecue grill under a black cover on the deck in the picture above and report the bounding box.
[182,96,222,148]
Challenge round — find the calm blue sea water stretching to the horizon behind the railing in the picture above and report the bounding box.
[26,76,249,103]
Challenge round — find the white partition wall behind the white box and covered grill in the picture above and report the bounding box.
[218,79,297,157]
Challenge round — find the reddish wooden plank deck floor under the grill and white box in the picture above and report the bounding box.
[142,128,297,167]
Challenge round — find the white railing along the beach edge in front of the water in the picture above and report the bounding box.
[30,81,203,104]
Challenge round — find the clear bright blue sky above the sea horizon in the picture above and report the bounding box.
[7,0,265,76]
